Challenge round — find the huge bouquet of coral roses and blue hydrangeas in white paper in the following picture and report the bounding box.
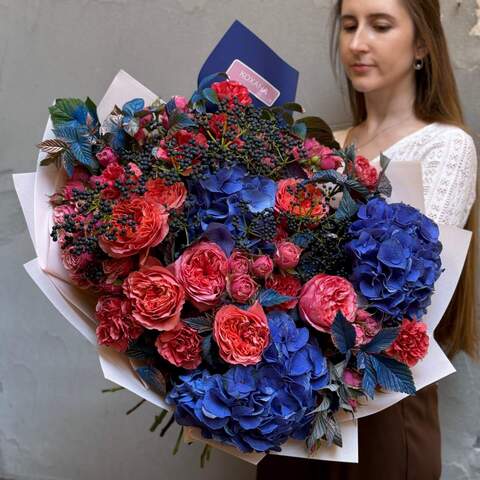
[16,72,469,461]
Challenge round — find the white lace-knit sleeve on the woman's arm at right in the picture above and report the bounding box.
[422,128,477,228]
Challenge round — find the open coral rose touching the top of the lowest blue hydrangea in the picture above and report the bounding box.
[213,302,270,366]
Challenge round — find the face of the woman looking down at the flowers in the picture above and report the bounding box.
[340,0,417,93]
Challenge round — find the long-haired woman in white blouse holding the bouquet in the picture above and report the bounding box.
[257,0,477,480]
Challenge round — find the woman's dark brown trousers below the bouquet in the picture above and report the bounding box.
[257,384,441,480]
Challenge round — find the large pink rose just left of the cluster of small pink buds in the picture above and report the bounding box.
[169,242,228,312]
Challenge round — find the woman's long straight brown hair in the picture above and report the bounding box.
[330,0,480,360]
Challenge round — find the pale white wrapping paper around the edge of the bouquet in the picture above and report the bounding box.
[14,70,471,464]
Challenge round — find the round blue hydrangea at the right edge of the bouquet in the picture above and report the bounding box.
[346,198,442,319]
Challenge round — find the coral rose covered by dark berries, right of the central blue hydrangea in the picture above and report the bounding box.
[275,178,329,222]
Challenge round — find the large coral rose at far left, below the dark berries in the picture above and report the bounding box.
[99,197,168,258]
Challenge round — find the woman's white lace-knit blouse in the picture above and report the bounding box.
[337,123,477,228]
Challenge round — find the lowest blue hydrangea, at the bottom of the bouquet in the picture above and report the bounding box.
[166,312,329,452]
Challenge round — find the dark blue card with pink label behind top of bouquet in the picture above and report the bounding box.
[198,20,298,107]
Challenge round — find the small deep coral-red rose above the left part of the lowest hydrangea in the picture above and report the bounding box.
[155,321,202,370]
